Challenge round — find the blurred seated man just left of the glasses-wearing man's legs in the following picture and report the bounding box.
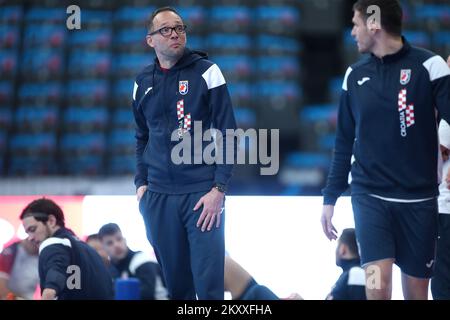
[98,223,167,300]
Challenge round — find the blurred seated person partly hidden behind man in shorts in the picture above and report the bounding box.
[327,228,366,300]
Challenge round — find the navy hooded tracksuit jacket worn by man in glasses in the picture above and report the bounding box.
[133,48,237,194]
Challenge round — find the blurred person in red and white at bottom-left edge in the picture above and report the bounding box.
[0,239,39,300]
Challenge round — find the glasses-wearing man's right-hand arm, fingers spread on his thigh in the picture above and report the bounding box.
[194,64,238,231]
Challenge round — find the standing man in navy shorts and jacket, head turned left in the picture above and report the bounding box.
[321,0,450,299]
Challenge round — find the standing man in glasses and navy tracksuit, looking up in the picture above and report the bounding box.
[133,7,236,300]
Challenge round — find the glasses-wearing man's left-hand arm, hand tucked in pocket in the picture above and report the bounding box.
[132,82,149,200]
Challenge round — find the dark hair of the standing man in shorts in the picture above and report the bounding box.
[353,0,403,36]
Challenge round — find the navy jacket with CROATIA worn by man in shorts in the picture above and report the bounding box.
[323,38,450,205]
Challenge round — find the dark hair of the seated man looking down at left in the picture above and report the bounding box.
[20,198,65,228]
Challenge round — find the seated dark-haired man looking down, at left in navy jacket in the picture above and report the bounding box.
[20,198,113,300]
